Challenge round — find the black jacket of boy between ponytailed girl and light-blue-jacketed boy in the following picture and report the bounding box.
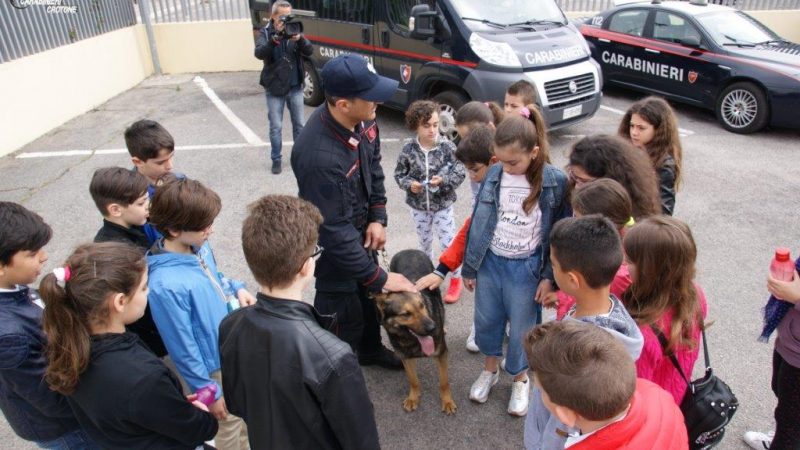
[94,219,167,358]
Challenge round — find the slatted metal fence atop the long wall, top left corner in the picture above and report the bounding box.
[0,0,136,64]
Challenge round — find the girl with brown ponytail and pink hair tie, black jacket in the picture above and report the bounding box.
[41,242,217,450]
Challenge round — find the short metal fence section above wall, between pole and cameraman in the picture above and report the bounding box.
[140,0,250,23]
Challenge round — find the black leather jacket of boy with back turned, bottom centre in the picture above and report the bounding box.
[219,293,380,450]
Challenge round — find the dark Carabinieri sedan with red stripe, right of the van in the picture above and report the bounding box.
[581,0,800,134]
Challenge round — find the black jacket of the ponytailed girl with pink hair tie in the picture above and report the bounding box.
[67,333,218,450]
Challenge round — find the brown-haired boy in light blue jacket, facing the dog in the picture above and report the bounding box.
[147,179,255,450]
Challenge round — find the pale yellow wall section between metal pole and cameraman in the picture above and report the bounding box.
[153,19,262,73]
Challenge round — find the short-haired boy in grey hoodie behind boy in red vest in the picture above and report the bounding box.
[525,214,644,450]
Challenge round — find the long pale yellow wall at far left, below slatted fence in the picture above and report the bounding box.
[0,25,153,156]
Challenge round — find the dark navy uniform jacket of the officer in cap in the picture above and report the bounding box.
[292,103,387,292]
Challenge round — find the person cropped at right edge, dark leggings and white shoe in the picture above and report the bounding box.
[744,255,800,449]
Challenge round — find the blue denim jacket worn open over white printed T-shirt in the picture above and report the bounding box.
[461,164,572,280]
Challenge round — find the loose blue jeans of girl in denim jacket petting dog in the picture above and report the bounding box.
[475,247,541,376]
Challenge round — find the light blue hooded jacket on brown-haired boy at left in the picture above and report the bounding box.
[147,239,245,399]
